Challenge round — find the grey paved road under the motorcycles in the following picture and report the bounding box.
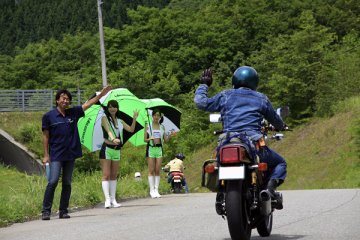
[0,189,360,240]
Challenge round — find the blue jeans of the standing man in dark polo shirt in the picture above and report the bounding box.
[42,160,75,213]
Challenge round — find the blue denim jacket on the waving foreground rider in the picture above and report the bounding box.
[194,84,284,141]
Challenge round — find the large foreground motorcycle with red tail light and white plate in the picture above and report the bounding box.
[202,109,288,240]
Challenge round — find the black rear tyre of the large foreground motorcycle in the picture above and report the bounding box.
[225,180,251,240]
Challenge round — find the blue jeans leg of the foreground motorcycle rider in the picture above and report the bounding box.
[258,147,286,181]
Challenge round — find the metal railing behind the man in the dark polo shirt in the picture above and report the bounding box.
[0,89,83,112]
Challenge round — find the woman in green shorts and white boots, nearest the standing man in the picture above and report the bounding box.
[100,100,139,208]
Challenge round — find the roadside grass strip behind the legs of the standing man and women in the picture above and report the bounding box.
[0,165,169,227]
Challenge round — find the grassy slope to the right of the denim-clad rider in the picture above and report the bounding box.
[272,98,360,189]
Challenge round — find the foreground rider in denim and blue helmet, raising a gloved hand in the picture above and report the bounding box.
[194,66,286,209]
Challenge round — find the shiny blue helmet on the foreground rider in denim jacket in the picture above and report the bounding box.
[232,66,259,90]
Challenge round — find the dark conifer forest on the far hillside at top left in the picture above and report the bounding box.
[0,0,169,54]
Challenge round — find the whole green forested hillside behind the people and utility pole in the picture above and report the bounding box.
[0,0,360,152]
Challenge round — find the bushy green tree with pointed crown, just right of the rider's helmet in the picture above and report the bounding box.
[251,11,334,120]
